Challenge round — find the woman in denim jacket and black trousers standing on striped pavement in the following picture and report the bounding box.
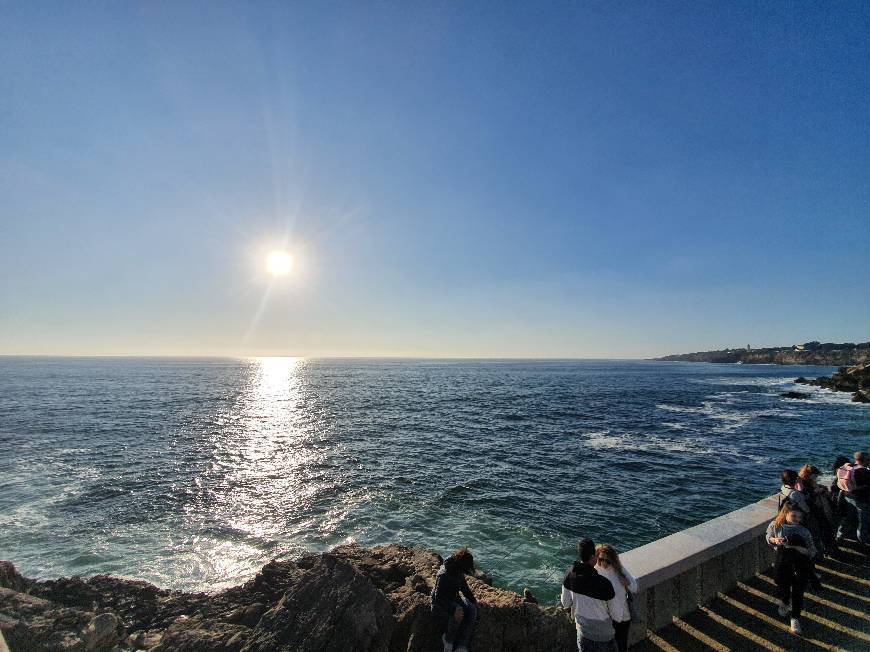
[765,502,816,634]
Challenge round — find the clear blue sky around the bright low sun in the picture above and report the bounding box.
[0,0,870,357]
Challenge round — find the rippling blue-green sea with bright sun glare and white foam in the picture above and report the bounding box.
[0,357,870,599]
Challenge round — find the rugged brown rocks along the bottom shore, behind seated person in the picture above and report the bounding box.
[0,545,576,652]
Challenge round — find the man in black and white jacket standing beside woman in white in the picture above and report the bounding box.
[562,539,616,652]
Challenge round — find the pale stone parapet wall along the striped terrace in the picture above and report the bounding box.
[620,496,777,642]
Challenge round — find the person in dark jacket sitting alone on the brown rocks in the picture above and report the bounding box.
[432,548,477,652]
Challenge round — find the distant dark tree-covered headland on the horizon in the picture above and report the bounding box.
[655,342,870,367]
